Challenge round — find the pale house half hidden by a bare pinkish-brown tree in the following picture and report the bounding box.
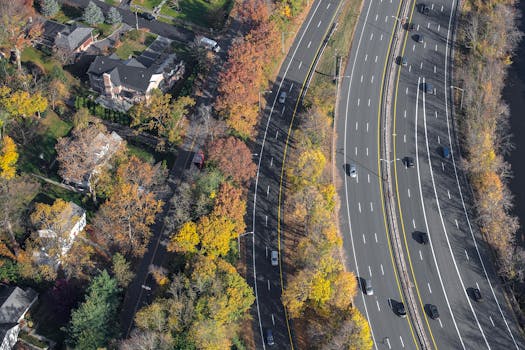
[59,127,124,192]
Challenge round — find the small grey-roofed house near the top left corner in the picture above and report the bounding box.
[40,20,95,55]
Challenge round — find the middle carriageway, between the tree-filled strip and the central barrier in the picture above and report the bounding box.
[335,0,420,349]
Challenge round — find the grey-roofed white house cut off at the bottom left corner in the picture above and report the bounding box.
[0,285,38,350]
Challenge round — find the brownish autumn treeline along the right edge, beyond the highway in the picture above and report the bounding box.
[455,0,525,307]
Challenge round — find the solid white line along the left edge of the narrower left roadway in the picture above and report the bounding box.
[252,1,321,350]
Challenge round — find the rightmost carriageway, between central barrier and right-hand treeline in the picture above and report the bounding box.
[392,0,525,349]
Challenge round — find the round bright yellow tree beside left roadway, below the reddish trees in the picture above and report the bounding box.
[197,216,236,257]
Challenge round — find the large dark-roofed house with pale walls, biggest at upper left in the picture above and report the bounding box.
[88,37,185,112]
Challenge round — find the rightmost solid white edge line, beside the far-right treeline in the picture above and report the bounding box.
[445,0,519,344]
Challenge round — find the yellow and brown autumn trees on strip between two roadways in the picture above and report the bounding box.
[283,105,372,350]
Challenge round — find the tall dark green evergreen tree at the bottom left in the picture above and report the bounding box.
[67,270,120,350]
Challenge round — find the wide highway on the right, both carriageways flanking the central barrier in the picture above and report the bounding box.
[336,0,524,349]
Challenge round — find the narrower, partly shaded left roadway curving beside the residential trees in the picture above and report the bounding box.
[248,0,341,349]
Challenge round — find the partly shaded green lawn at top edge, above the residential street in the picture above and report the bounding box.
[160,0,233,29]
